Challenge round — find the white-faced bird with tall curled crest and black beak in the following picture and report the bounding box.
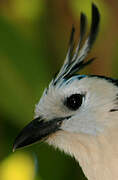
[13,3,118,180]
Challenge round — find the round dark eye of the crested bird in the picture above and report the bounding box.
[64,94,83,111]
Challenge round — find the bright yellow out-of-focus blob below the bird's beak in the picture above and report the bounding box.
[0,153,35,180]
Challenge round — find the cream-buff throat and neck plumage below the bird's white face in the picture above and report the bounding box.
[48,120,118,180]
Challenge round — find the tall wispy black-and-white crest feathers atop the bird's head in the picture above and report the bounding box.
[51,4,100,85]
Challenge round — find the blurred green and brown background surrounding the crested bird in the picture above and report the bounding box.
[0,0,118,180]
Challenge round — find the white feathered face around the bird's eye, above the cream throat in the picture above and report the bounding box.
[35,76,118,135]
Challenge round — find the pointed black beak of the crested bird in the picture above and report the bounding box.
[13,117,69,151]
